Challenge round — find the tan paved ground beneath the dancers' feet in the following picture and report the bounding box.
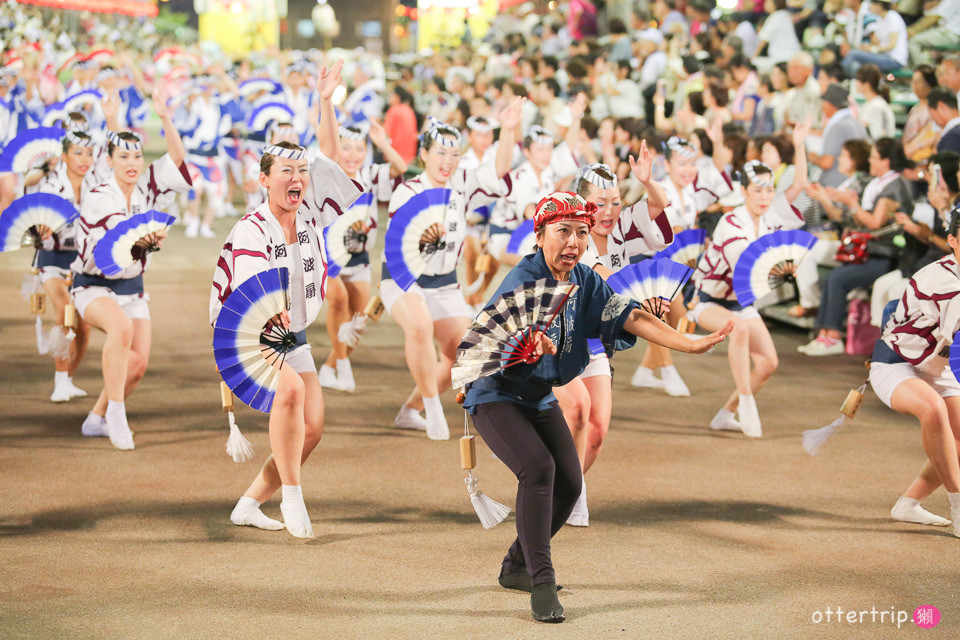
[0,221,960,639]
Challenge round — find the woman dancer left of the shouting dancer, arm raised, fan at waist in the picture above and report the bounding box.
[71,88,190,449]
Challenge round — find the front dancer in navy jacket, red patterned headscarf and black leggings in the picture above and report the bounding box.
[464,192,732,622]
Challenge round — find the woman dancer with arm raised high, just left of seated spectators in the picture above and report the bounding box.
[689,125,808,438]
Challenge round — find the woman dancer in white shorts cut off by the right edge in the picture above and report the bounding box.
[870,214,960,537]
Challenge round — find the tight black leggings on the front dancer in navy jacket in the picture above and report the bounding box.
[473,402,583,586]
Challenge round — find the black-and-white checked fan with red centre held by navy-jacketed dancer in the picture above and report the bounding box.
[451,278,579,389]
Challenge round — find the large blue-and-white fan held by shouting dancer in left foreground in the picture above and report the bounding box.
[213,268,298,413]
